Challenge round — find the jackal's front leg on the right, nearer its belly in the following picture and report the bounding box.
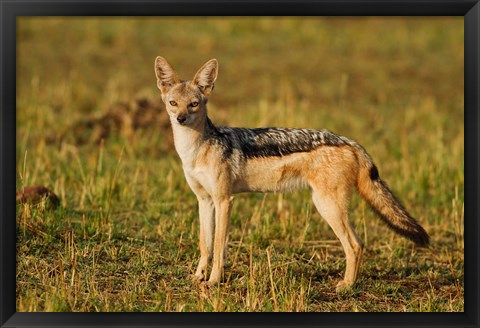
[208,196,233,286]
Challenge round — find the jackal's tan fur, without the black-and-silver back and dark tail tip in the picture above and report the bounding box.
[155,57,428,288]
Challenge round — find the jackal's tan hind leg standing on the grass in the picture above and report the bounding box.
[312,189,363,292]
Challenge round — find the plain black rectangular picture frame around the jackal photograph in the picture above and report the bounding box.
[0,0,480,327]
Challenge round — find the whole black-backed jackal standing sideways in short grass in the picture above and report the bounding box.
[155,57,429,289]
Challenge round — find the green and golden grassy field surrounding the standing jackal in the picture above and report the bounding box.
[16,17,464,312]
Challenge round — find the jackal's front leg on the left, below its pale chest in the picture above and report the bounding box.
[195,197,215,281]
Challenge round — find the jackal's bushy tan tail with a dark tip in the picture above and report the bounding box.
[353,144,430,247]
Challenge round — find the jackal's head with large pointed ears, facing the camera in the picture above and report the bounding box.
[155,56,218,126]
